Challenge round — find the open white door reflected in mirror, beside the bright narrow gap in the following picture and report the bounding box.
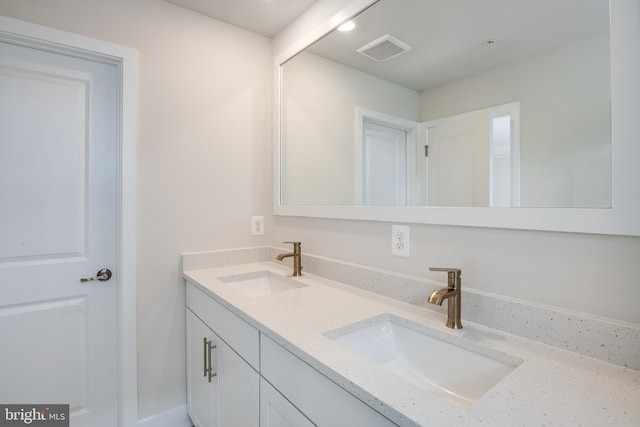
[428,110,491,206]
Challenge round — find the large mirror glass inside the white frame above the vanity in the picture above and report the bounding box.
[280,0,611,208]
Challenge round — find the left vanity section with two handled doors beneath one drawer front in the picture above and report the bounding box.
[186,285,260,427]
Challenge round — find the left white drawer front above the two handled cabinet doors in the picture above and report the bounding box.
[187,281,260,371]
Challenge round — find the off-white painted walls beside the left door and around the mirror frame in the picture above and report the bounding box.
[0,0,640,419]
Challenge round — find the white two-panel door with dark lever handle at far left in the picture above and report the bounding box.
[0,38,119,427]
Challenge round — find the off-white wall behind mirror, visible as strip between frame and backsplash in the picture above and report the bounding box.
[273,0,640,323]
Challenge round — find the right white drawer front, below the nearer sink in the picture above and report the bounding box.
[260,334,396,427]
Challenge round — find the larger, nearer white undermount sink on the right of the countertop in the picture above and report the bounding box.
[325,314,522,406]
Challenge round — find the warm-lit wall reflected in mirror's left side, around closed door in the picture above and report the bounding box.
[282,52,420,205]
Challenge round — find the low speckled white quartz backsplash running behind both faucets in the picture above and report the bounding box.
[183,246,640,370]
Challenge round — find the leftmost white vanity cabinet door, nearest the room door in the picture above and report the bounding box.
[187,310,218,427]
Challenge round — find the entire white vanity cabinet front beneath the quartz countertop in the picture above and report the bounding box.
[186,282,396,427]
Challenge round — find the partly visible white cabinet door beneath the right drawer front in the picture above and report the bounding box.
[260,378,315,427]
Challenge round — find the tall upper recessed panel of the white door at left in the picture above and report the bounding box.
[0,66,88,262]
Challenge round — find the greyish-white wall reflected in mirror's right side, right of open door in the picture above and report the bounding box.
[421,34,611,208]
